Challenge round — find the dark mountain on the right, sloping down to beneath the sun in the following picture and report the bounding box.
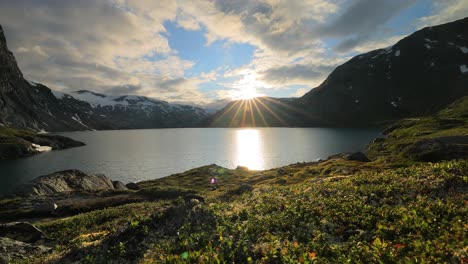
[206,18,468,127]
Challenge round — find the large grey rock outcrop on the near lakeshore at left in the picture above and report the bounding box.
[16,170,114,196]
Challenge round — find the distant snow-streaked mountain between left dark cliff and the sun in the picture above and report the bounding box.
[52,90,208,129]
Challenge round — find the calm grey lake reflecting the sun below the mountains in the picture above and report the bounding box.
[0,128,380,194]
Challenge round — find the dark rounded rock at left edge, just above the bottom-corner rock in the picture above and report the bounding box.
[0,222,45,243]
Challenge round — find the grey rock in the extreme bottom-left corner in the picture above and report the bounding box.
[0,237,52,263]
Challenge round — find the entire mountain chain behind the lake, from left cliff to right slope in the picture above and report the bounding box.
[0,18,468,131]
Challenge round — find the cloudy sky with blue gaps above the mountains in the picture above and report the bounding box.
[0,0,468,108]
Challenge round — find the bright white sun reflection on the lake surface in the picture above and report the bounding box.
[236,129,265,170]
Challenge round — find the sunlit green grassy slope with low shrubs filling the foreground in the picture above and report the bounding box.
[12,98,468,263]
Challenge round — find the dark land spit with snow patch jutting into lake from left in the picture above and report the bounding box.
[0,127,85,159]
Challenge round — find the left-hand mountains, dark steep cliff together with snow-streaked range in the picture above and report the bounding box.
[0,26,208,131]
